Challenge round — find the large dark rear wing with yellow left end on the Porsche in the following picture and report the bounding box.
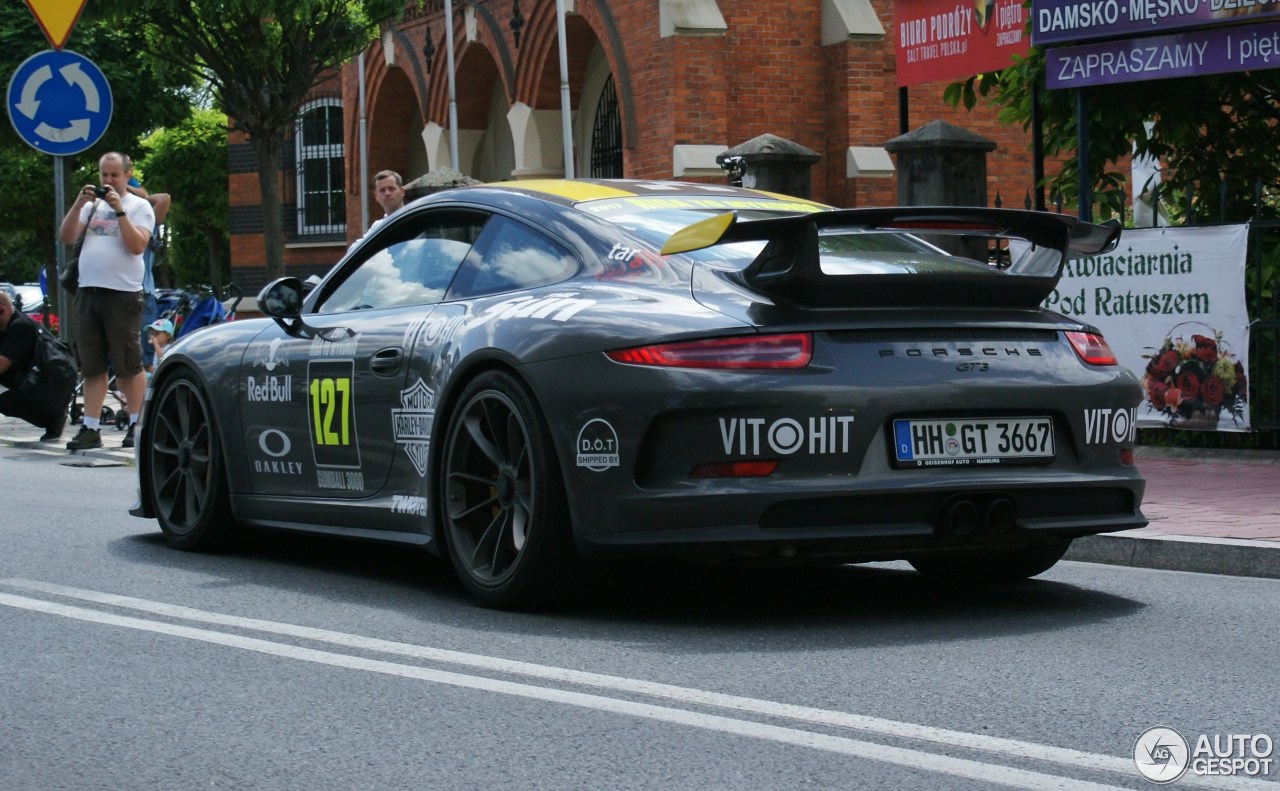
[662,206,1120,307]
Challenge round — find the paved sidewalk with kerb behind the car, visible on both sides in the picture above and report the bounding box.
[0,416,1280,579]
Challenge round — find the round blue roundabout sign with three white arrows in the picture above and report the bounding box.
[6,50,111,156]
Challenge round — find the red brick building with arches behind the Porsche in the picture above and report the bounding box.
[229,0,1033,293]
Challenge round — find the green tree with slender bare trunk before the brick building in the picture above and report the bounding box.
[97,0,404,278]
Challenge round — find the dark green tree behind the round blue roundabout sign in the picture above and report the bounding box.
[0,3,191,295]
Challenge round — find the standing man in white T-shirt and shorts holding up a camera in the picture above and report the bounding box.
[60,151,156,451]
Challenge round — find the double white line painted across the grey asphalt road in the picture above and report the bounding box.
[0,577,1276,791]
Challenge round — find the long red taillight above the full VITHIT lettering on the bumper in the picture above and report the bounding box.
[607,333,813,370]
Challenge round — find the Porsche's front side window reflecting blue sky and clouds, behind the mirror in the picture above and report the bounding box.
[316,212,486,314]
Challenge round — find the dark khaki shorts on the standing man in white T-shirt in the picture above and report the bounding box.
[76,288,142,379]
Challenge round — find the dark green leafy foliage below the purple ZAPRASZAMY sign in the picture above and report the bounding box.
[943,47,1280,221]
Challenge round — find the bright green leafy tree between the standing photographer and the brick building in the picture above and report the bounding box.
[141,109,230,293]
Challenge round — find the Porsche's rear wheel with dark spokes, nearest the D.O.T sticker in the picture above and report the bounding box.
[438,371,575,609]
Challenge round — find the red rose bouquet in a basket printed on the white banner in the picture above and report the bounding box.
[1142,324,1249,427]
